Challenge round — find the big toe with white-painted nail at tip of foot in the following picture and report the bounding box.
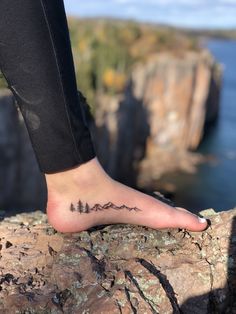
[176,207,208,231]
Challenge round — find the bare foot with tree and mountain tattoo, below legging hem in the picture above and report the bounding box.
[46,158,207,232]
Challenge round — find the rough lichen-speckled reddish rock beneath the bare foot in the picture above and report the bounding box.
[0,209,236,314]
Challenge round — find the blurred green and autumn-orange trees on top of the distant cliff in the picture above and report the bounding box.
[0,17,198,107]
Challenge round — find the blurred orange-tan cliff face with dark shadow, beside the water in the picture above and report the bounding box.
[95,51,221,183]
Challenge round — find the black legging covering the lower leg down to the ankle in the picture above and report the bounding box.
[0,0,95,173]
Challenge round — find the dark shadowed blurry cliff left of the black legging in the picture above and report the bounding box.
[0,89,46,210]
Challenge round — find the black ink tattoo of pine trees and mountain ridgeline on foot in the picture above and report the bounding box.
[70,200,141,214]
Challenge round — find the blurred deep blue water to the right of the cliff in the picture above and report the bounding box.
[157,40,236,211]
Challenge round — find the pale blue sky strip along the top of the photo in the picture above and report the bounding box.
[64,0,236,28]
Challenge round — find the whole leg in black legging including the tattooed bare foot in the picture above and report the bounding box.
[0,0,207,232]
